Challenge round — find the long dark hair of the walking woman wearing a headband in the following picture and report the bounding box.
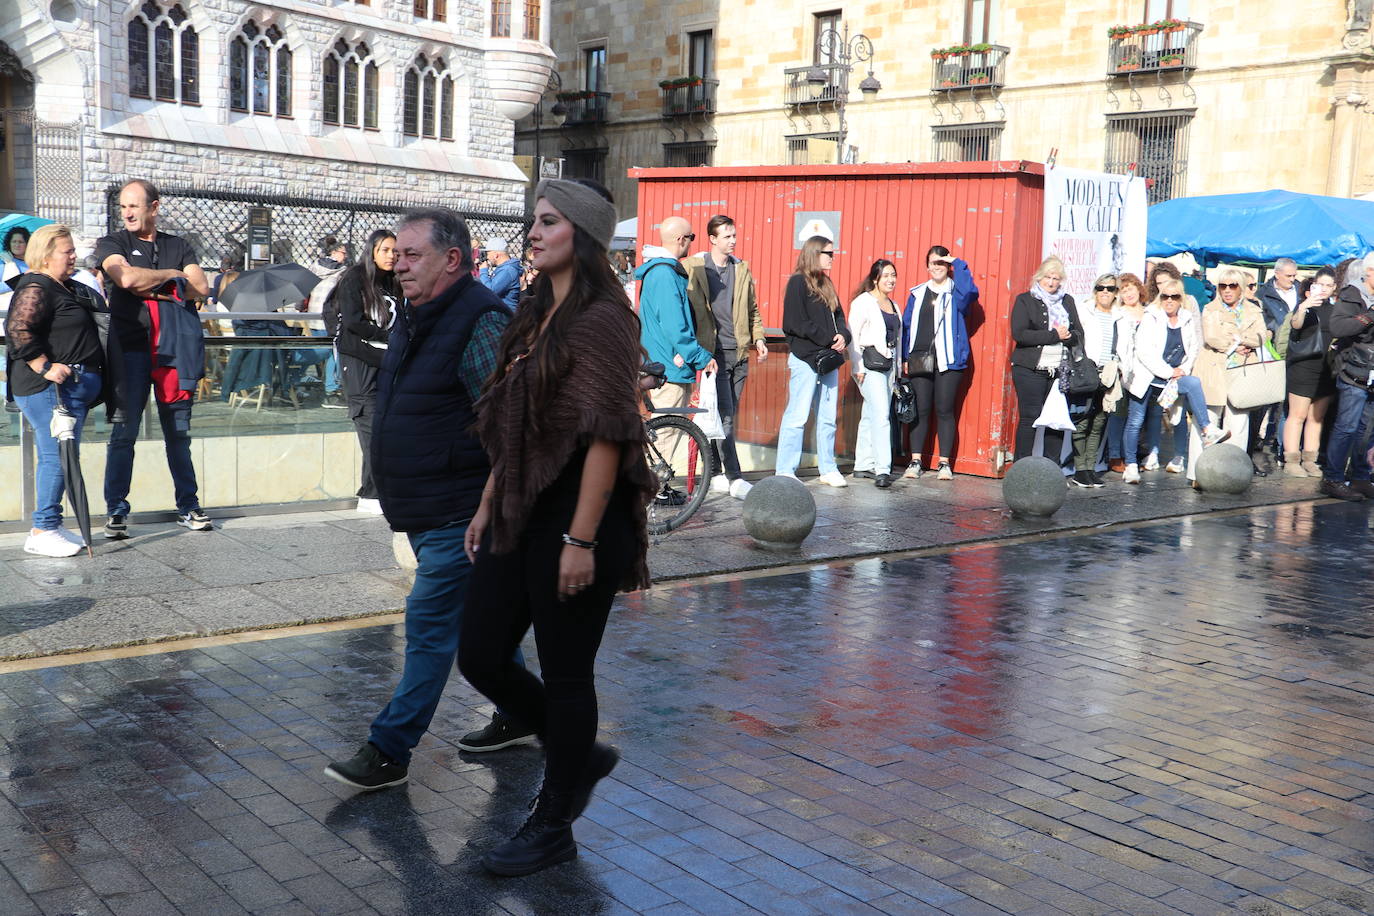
[482,179,639,428]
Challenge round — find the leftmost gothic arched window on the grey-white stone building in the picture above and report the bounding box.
[128,0,201,104]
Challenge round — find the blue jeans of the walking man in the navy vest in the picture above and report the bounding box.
[367,522,525,764]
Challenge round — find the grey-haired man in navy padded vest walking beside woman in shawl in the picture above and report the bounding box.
[324,207,534,790]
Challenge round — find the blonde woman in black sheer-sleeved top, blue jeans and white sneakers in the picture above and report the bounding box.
[5,225,104,556]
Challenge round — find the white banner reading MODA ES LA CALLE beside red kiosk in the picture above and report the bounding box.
[1044,168,1149,306]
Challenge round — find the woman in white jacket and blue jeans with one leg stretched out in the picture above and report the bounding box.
[1121,276,1230,483]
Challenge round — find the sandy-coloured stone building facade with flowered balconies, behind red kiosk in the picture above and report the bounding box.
[517,0,1374,211]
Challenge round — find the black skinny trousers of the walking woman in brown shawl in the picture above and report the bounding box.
[458,461,636,794]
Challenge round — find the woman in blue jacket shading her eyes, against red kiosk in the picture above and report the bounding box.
[901,244,978,481]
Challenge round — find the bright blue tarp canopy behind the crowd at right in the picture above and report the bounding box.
[1146,191,1374,268]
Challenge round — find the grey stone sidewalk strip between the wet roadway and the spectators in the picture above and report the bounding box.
[0,471,1316,659]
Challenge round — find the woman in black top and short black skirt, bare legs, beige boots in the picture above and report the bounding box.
[1283,268,1336,477]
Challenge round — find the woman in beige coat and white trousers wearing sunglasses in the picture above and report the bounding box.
[1189,268,1270,481]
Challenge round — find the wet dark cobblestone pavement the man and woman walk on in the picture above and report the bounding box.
[0,503,1374,916]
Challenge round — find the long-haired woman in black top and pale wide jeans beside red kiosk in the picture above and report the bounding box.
[775,235,853,486]
